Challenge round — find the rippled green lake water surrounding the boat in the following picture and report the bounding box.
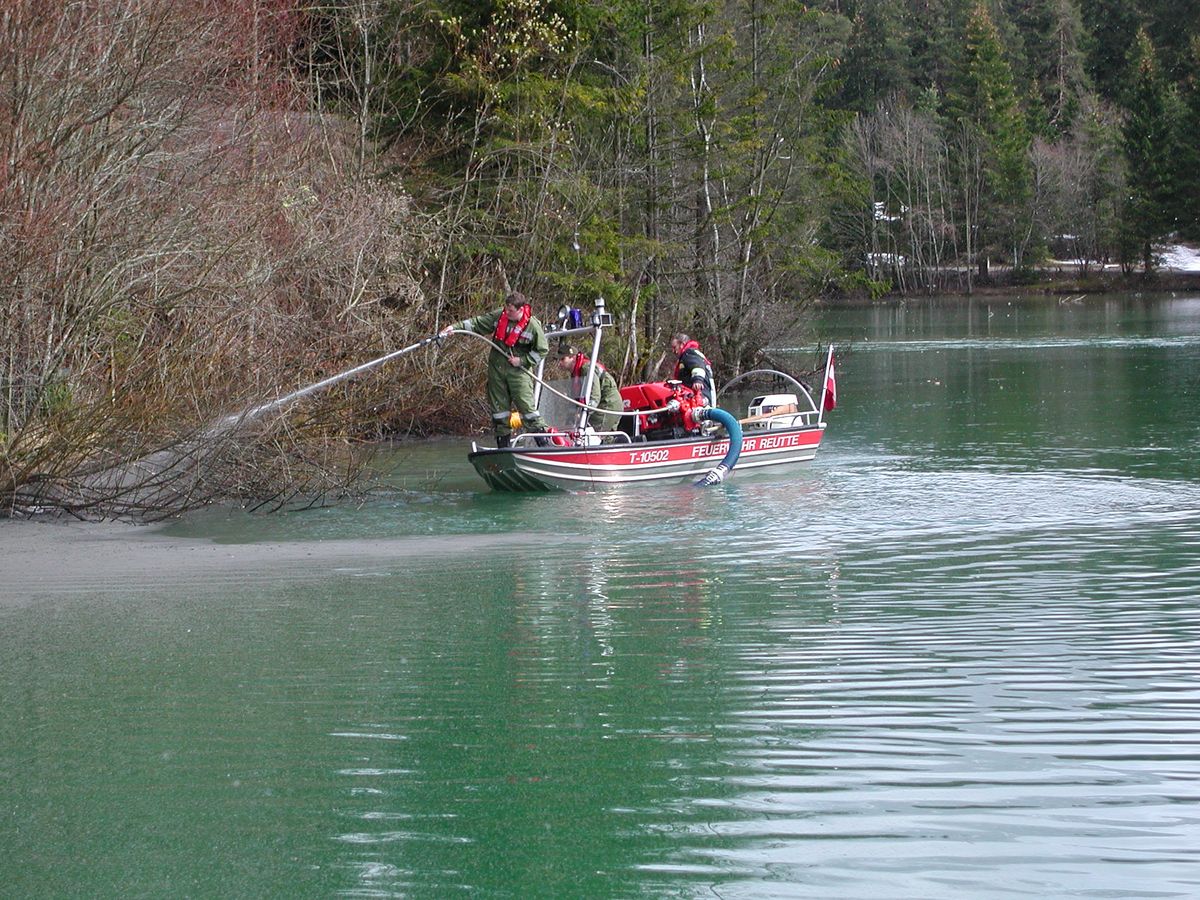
[0,295,1200,900]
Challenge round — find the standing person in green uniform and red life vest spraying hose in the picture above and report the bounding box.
[439,292,550,446]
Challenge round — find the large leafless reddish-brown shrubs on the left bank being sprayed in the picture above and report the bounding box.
[0,0,446,517]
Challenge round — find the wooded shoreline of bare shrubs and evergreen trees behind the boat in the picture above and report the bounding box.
[0,0,1200,517]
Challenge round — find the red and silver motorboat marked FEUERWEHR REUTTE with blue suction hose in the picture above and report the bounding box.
[467,298,834,491]
